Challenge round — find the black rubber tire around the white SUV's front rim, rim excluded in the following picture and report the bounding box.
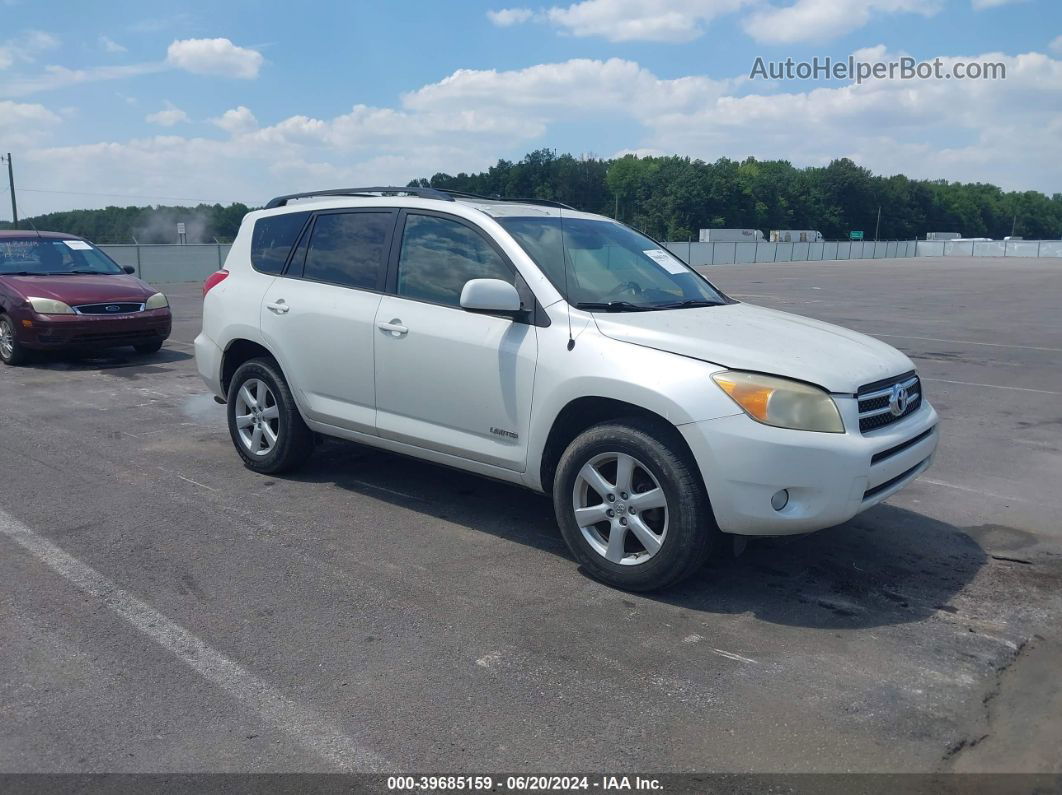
[553,417,719,591]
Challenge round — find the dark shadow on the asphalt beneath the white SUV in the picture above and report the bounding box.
[287,440,988,629]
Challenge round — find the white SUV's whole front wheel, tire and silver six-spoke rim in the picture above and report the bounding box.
[553,418,719,591]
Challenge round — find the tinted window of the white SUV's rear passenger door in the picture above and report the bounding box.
[303,212,394,290]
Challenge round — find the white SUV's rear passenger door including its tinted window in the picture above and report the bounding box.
[261,209,397,433]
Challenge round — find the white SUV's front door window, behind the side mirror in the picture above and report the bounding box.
[398,214,515,307]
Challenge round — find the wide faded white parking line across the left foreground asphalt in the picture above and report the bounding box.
[0,511,386,771]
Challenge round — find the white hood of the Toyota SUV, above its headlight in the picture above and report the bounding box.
[594,304,914,393]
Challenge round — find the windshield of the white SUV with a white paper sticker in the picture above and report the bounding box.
[497,218,729,312]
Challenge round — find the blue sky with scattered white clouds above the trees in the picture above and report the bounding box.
[0,0,1062,217]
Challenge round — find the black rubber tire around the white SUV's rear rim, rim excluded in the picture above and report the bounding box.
[225,359,313,474]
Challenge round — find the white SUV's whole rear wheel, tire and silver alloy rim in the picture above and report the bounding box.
[226,359,313,474]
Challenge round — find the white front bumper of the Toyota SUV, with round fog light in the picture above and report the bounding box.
[679,398,940,535]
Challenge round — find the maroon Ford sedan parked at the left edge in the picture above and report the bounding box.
[0,231,172,364]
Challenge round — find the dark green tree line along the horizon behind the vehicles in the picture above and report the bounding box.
[0,150,1062,243]
